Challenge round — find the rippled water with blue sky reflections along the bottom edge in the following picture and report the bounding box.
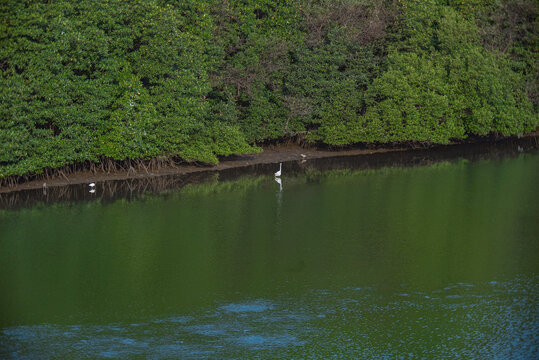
[0,277,539,359]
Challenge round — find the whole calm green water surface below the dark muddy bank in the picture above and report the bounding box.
[0,145,539,359]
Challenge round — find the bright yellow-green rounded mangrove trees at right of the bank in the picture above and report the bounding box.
[354,1,538,143]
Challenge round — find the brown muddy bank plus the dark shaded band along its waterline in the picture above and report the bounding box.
[0,135,539,209]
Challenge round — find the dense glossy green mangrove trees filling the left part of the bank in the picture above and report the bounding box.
[0,1,251,176]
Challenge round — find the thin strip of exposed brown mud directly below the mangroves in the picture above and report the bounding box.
[0,131,539,194]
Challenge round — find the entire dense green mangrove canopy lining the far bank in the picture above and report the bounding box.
[0,0,539,178]
